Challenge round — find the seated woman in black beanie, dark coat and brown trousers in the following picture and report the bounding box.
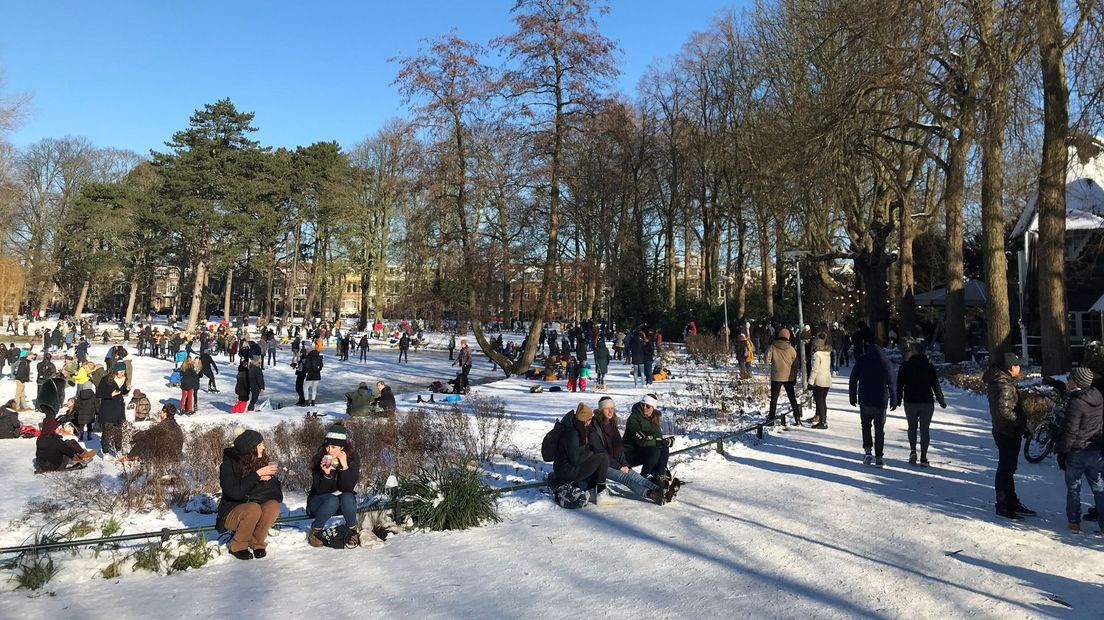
[215,430,284,559]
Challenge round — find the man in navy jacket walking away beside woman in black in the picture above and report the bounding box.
[849,342,898,467]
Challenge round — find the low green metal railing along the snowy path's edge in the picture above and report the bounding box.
[0,424,763,555]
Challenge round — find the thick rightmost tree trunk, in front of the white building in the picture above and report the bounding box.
[1037,0,1071,375]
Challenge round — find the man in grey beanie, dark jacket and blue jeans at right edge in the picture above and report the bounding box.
[1054,366,1104,533]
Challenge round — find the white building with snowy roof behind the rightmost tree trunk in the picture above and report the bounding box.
[1012,148,1104,360]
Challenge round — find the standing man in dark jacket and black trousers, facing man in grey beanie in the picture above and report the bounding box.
[981,353,1036,520]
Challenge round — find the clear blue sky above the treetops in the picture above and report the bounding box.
[0,0,749,154]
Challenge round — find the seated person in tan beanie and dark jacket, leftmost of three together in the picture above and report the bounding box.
[552,403,609,504]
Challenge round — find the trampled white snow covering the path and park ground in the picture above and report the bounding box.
[0,339,1104,619]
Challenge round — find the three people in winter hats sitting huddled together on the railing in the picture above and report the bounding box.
[552,394,681,505]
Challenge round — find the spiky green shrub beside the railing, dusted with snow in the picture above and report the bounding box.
[397,459,498,531]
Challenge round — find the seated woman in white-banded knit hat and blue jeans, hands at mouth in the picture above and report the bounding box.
[307,424,360,547]
